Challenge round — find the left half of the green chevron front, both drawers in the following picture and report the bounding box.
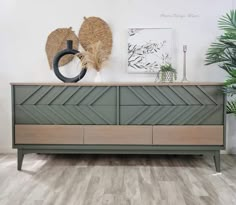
[15,86,117,125]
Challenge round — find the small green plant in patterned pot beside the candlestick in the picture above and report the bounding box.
[156,63,177,82]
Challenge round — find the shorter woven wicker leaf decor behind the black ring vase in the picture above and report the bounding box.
[45,27,79,69]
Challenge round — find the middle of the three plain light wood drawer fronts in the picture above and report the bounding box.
[84,126,152,145]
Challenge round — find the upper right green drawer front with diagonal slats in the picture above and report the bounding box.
[120,85,223,106]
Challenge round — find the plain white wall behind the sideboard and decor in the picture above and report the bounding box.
[0,0,236,153]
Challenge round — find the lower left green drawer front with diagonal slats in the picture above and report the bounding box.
[15,105,117,125]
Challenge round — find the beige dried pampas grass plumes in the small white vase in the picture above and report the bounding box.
[78,41,108,72]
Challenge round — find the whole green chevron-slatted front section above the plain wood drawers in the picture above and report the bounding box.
[14,85,224,125]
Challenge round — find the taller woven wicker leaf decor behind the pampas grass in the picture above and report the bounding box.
[78,17,112,57]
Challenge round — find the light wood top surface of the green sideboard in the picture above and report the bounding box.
[11,81,224,86]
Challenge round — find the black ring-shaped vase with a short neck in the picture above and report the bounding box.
[53,40,87,83]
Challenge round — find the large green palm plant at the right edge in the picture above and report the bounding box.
[206,10,236,114]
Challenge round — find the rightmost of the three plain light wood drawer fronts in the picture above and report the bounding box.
[153,126,223,145]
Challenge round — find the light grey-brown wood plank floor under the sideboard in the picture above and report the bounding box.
[0,154,236,205]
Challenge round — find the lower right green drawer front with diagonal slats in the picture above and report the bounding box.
[120,105,224,125]
